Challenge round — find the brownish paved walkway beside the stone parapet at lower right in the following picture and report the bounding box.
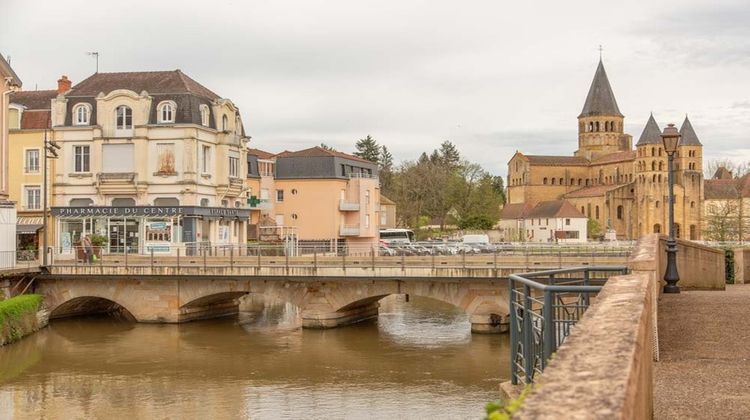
[654,285,750,419]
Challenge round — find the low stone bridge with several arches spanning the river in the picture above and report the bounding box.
[36,256,625,333]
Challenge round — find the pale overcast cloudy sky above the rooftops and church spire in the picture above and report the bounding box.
[0,0,750,175]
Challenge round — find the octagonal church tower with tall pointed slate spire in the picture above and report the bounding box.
[575,59,633,160]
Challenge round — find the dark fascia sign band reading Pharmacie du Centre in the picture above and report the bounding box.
[52,206,250,218]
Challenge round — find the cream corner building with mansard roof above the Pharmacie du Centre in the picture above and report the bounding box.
[51,70,250,258]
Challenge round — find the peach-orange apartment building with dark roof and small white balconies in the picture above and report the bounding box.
[247,147,381,252]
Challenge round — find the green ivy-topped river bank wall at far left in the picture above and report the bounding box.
[0,295,48,346]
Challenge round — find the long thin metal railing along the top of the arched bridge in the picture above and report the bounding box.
[52,242,630,270]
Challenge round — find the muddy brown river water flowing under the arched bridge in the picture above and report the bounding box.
[0,296,509,420]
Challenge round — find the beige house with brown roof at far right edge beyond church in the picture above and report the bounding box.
[703,167,750,242]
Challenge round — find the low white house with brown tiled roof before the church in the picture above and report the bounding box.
[498,200,588,243]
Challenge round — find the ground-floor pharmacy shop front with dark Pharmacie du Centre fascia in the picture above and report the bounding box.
[52,206,250,259]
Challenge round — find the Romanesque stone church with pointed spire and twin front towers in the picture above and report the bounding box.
[507,61,703,240]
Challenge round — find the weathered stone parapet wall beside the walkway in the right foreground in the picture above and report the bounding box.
[516,234,728,419]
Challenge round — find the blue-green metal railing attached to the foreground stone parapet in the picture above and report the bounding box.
[508,266,628,385]
